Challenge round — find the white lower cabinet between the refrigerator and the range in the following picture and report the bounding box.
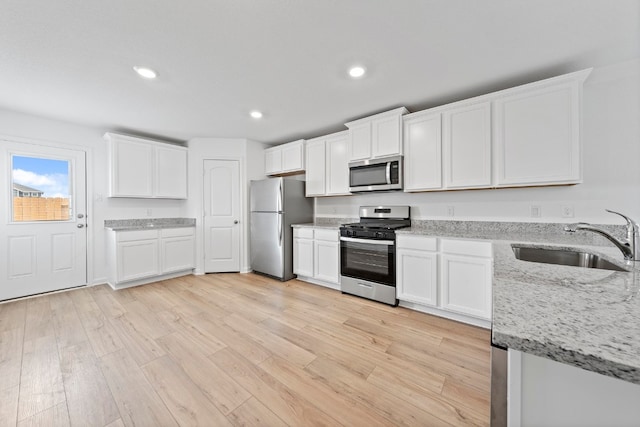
[293,227,340,289]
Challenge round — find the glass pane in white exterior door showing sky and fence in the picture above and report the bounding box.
[11,155,72,222]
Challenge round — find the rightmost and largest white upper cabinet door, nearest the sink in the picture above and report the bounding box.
[495,82,581,186]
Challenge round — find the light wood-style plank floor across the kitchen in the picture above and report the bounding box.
[0,274,489,426]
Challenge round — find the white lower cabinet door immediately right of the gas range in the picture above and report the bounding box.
[396,249,438,307]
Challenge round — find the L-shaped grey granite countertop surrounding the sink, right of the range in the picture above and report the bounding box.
[397,221,640,384]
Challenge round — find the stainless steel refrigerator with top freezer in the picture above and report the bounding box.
[250,178,313,281]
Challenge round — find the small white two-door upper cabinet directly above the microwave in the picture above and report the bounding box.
[345,107,408,161]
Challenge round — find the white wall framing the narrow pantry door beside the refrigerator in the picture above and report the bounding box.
[187,138,265,274]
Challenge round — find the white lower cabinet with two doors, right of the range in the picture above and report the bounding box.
[396,234,493,326]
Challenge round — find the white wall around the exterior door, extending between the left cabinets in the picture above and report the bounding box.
[0,109,187,284]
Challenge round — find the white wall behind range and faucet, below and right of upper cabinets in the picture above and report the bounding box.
[316,59,640,224]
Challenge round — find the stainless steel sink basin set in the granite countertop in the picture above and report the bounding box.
[511,246,627,271]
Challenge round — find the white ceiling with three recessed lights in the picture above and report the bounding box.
[0,0,640,144]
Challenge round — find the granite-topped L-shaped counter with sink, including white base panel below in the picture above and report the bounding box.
[398,221,640,426]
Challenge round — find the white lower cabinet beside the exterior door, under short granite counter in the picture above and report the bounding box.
[108,227,195,288]
